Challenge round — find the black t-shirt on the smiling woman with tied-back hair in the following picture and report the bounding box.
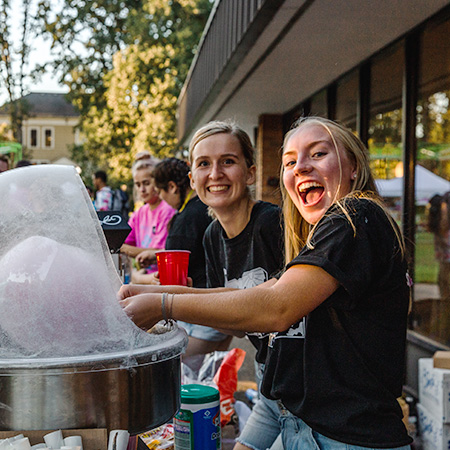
[203,202,284,362]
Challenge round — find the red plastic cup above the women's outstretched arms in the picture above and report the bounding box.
[156,250,191,286]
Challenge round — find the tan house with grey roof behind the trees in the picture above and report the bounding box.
[0,92,81,164]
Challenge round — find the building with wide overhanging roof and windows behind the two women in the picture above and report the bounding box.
[178,0,450,396]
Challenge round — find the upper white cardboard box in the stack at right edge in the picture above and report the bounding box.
[419,358,450,423]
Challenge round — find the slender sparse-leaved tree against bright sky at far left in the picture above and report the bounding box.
[0,0,42,143]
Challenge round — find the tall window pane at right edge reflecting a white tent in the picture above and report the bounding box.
[412,15,450,345]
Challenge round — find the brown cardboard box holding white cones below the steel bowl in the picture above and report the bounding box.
[0,428,108,450]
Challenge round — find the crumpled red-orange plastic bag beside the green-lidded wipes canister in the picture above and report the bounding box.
[213,348,245,427]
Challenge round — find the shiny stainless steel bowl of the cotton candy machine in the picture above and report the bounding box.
[0,330,186,434]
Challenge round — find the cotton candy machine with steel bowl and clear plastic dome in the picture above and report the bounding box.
[0,166,187,433]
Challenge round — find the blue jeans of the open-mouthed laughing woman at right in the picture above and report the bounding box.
[280,406,411,450]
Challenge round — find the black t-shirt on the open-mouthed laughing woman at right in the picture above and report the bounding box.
[262,199,411,448]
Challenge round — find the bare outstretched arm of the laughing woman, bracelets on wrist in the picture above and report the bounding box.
[119,265,339,332]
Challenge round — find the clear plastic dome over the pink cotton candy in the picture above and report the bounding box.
[0,165,186,360]
